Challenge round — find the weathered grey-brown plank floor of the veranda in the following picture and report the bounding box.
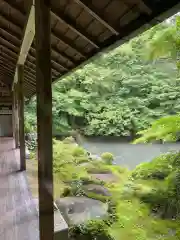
[0,138,39,240]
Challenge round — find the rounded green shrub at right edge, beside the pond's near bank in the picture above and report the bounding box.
[129,152,180,219]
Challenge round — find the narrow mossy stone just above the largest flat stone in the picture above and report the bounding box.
[83,184,111,197]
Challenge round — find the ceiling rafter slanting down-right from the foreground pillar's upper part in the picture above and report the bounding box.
[51,8,99,49]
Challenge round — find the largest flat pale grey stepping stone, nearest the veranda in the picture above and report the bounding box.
[56,197,108,225]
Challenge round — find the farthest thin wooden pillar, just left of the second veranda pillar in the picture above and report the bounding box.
[12,86,19,148]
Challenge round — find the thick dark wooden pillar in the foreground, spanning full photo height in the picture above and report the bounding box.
[35,0,54,240]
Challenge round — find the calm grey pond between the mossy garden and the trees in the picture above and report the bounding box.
[81,138,180,169]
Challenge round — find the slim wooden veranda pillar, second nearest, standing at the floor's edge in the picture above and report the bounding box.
[17,65,26,171]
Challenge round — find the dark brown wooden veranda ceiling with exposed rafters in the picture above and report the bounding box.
[0,0,180,102]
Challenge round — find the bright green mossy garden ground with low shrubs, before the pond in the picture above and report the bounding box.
[27,139,180,240]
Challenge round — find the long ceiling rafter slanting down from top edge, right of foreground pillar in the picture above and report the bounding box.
[75,0,119,35]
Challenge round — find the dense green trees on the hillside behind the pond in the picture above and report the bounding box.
[26,19,180,138]
